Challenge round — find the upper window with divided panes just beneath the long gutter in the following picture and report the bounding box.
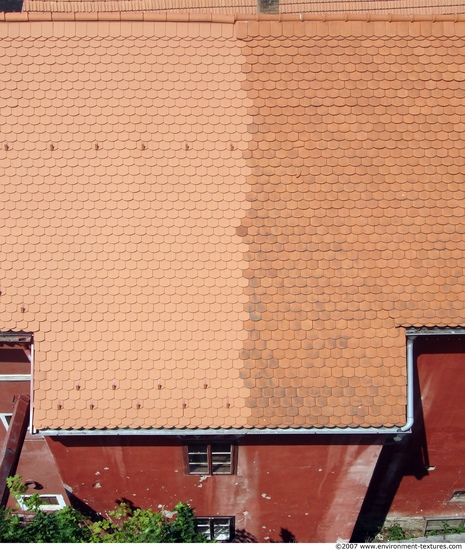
[184,441,237,475]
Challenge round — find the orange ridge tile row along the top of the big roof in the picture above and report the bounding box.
[0,11,465,24]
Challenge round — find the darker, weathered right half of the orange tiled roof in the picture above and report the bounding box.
[238,22,465,427]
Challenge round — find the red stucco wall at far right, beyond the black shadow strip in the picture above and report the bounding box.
[390,336,465,517]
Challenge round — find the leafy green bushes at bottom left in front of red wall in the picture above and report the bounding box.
[0,476,207,543]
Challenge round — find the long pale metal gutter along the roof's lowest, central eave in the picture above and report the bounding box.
[34,426,411,437]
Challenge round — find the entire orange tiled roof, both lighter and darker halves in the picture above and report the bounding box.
[0,13,465,430]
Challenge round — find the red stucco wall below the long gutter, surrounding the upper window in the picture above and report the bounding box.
[49,436,381,542]
